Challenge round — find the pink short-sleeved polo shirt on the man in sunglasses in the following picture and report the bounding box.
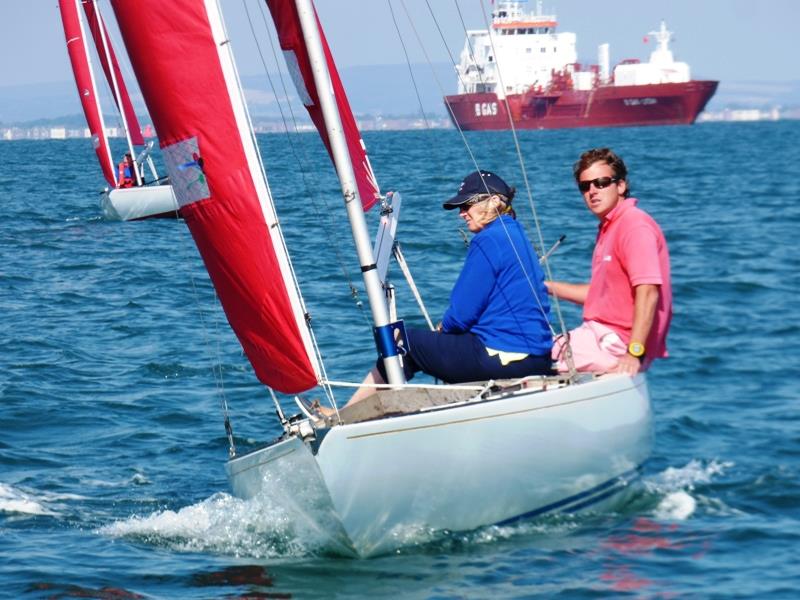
[583,198,672,367]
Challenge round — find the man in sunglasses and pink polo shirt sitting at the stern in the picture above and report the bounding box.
[546,148,672,375]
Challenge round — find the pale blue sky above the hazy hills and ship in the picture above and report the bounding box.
[0,0,800,87]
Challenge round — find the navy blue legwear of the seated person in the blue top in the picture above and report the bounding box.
[376,329,554,383]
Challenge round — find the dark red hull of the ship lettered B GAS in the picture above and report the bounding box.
[445,81,719,131]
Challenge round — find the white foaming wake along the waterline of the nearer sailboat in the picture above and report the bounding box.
[94,460,732,559]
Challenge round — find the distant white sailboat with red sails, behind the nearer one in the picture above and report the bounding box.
[58,0,178,221]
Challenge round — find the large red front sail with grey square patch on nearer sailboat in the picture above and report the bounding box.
[112,0,319,393]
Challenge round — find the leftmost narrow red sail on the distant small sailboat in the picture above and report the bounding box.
[58,0,117,186]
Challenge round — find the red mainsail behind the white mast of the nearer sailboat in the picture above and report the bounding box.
[266,0,380,211]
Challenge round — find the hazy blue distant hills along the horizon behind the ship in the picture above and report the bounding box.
[0,64,800,126]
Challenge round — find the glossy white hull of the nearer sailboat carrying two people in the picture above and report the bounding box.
[227,375,652,556]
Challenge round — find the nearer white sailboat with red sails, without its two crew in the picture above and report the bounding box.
[112,0,652,556]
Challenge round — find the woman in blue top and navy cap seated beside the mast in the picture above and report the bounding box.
[340,171,553,405]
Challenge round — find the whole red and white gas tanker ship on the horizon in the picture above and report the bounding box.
[445,0,719,130]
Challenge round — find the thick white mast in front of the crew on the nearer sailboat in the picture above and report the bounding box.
[295,0,405,385]
